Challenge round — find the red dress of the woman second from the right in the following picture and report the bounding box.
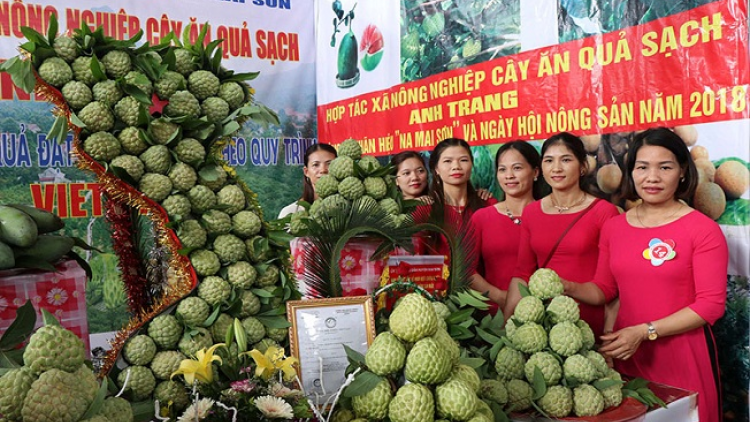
[513,200,618,338]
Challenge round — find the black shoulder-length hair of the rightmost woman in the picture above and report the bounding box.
[620,127,698,204]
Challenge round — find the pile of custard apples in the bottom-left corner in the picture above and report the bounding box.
[0,311,133,422]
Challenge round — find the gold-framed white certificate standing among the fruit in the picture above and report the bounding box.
[286,296,375,405]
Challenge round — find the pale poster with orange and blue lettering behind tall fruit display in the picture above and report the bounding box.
[0,0,317,333]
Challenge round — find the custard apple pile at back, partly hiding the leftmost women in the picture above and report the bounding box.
[291,139,407,234]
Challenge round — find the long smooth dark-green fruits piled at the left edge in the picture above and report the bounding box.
[0,204,76,270]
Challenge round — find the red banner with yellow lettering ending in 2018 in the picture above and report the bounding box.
[318,1,750,155]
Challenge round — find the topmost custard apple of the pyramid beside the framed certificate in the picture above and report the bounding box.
[388,293,437,343]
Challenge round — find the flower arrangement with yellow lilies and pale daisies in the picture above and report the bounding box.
[167,343,313,422]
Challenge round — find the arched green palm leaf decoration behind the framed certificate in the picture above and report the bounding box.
[303,200,475,298]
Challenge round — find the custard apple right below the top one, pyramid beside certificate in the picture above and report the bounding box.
[406,336,453,384]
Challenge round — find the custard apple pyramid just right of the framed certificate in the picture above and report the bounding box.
[334,293,495,422]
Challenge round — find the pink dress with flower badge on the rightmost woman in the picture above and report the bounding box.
[595,211,728,422]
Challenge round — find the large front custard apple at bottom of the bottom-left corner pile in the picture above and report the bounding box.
[19,369,90,422]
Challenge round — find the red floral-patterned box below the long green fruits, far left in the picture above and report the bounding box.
[0,260,90,354]
